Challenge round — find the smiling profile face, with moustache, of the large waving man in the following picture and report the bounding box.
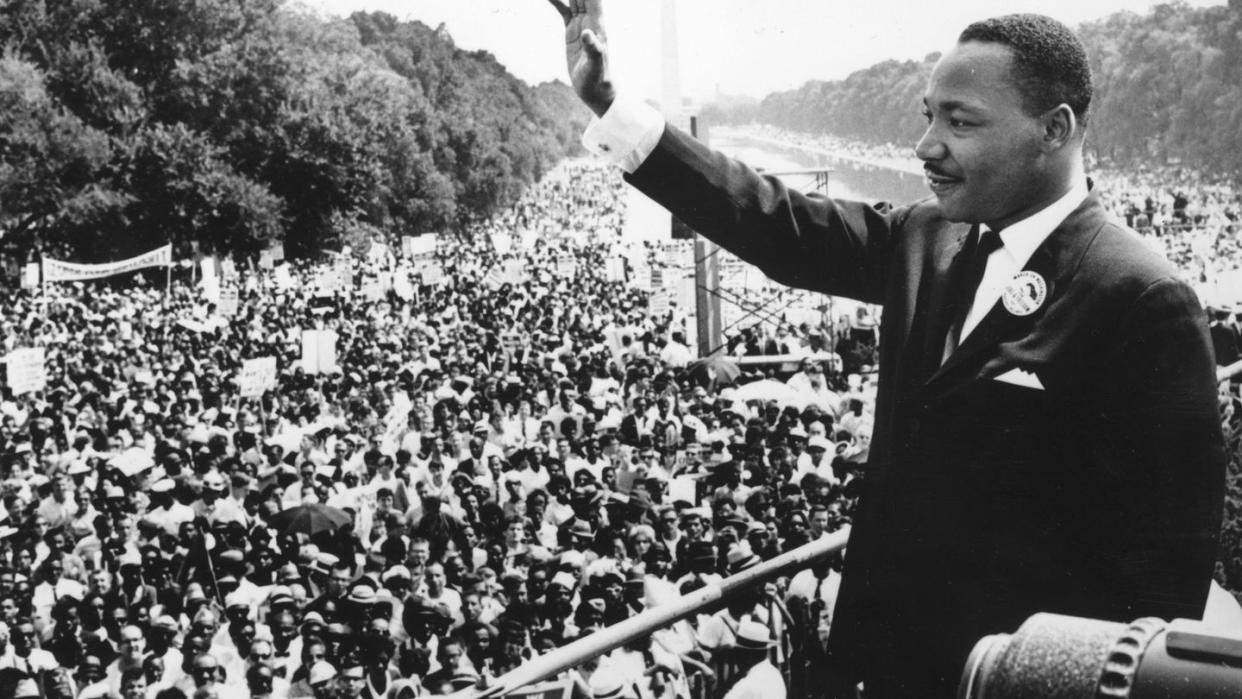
[914,41,1063,227]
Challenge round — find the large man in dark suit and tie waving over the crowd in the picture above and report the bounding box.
[551,0,1225,698]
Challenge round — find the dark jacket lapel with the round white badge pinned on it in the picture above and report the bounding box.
[928,194,1103,384]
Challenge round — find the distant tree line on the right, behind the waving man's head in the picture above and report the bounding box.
[703,0,1242,183]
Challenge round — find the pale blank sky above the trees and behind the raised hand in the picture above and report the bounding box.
[299,0,1223,102]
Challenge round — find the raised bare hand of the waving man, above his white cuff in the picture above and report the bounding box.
[548,0,616,117]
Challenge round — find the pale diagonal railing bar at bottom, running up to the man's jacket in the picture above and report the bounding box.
[453,526,850,699]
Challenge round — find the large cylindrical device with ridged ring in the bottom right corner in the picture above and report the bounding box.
[958,613,1242,699]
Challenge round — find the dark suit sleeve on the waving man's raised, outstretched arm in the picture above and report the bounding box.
[626,127,905,303]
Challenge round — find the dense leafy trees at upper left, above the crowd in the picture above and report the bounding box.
[0,0,589,262]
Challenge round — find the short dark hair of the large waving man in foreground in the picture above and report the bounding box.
[958,14,1092,125]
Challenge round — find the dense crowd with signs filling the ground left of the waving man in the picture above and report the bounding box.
[0,163,874,699]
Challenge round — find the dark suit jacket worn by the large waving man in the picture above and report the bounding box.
[626,128,1226,698]
